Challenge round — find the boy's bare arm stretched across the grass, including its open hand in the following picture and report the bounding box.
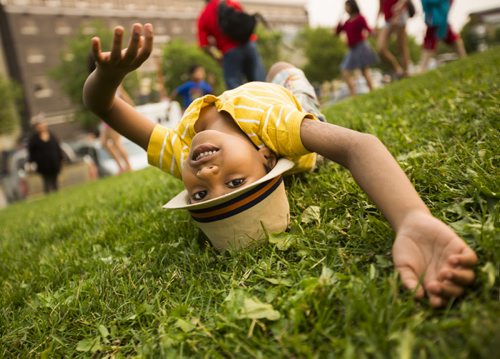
[301,119,477,307]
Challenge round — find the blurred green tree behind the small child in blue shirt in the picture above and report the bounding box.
[161,39,224,93]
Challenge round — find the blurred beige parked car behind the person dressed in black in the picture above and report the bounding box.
[0,142,97,202]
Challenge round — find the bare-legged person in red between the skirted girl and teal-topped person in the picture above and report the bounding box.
[377,0,410,78]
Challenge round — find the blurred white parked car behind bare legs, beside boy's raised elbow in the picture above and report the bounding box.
[71,137,148,177]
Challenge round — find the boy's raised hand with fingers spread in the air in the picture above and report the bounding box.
[92,23,153,80]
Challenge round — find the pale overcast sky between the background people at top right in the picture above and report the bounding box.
[308,0,500,40]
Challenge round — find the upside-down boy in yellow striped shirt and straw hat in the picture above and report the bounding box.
[84,24,477,307]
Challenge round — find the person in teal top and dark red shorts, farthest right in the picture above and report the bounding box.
[420,0,466,72]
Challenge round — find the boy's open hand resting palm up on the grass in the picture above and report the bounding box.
[392,212,477,307]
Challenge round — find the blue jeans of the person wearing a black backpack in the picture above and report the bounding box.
[222,41,266,90]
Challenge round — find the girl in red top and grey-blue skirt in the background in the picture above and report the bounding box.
[336,0,378,96]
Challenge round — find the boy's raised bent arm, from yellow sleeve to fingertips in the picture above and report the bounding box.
[83,24,155,149]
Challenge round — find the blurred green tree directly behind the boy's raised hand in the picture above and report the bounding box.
[50,20,139,129]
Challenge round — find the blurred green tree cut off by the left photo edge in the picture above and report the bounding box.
[0,75,21,135]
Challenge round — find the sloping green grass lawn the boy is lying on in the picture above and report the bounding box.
[0,48,500,358]
